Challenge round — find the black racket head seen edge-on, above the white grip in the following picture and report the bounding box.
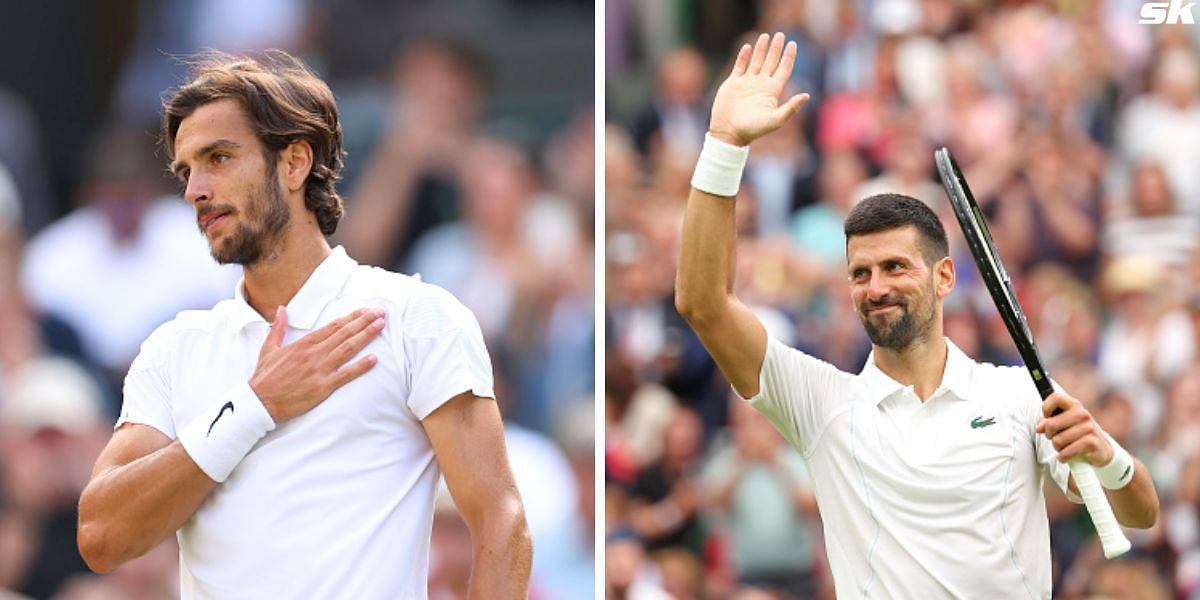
[934,148,1054,397]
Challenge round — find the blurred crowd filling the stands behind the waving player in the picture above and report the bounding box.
[604,0,1200,600]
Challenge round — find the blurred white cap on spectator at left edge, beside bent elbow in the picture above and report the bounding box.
[0,358,102,433]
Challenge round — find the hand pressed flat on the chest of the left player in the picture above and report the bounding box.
[250,306,384,422]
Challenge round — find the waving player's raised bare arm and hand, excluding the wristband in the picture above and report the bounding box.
[676,34,808,397]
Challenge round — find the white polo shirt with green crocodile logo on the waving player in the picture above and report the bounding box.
[749,338,1069,600]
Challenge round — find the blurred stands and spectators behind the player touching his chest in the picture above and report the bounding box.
[0,0,595,599]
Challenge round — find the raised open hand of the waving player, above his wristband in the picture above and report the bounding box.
[708,34,809,146]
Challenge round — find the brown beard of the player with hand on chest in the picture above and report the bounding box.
[200,162,292,266]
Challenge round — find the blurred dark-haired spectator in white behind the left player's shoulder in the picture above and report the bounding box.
[22,126,238,389]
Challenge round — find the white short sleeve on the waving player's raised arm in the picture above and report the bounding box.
[748,337,851,456]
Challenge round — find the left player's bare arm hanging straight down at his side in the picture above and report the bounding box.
[421,392,533,599]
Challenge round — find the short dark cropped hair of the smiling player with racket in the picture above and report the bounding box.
[845,193,950,264]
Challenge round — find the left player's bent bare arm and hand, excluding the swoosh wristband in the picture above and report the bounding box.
[78,308,383,572]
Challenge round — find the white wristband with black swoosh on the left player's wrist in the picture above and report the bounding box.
[179,383,275,484]
